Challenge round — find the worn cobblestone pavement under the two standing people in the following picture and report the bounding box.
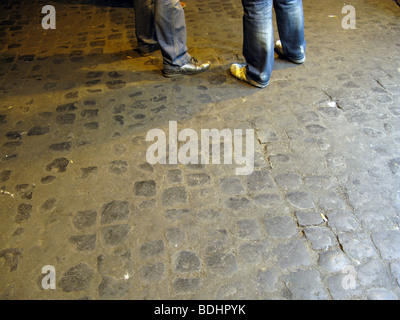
[0,0,400,299]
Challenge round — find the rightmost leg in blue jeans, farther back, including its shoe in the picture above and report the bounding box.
[274,0,306,63]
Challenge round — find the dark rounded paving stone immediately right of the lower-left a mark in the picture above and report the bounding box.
[58,263,93,292]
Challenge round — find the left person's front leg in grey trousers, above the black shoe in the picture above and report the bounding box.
[154,0,191,66]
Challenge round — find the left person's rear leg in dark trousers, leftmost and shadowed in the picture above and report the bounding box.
[133,0,159,55]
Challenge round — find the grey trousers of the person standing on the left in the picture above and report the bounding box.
[133,0,191,66]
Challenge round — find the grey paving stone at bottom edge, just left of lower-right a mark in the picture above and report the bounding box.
[283,270,329,300]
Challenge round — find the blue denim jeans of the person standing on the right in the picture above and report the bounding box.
[242,0,306,85]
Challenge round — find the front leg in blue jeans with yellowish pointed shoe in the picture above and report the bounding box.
[231,0,274,87]
